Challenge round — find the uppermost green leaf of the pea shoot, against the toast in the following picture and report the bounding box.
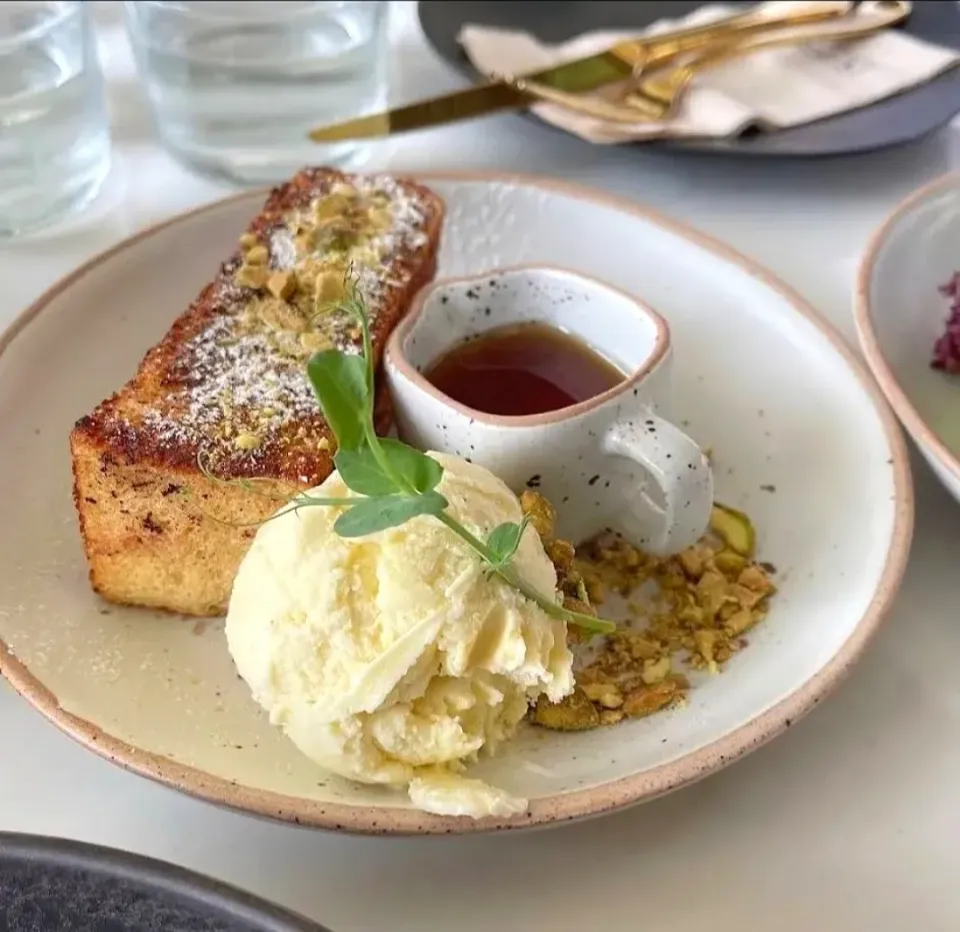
[307,349,373,450]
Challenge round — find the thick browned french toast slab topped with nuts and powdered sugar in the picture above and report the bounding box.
[70,168,444,616]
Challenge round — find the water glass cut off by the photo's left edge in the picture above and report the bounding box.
[0,0,110,238]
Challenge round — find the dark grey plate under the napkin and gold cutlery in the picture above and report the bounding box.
[418,0,960,157]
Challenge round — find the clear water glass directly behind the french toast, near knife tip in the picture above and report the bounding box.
[126,0,387,184]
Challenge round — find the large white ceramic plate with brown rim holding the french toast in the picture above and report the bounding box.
[0,174,913,832]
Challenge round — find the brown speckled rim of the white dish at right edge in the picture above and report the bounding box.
[853,171,960,482]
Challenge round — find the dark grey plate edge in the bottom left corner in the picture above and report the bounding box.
[0,833,325,932]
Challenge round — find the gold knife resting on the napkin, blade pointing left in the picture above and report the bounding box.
[309,3,851,142]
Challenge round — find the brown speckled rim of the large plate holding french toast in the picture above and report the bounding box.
[0,170,914,835]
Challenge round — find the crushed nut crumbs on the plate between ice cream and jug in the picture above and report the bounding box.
[521,490,776,731]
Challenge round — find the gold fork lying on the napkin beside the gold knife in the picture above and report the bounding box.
[510,0,912,124]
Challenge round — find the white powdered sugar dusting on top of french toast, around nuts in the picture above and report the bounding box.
[136,176,429,474]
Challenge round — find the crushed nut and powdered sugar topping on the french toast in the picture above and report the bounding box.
[144,176,427,458]
